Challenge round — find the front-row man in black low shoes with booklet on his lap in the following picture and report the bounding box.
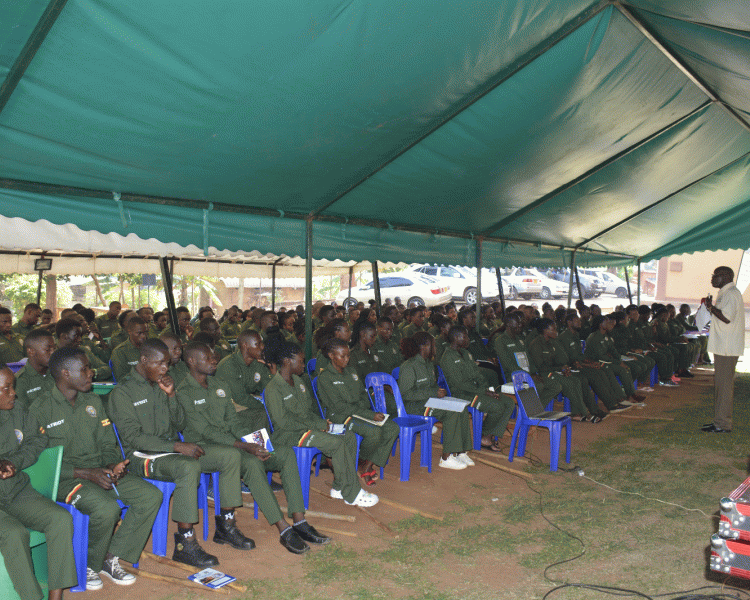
[178,342,330,554]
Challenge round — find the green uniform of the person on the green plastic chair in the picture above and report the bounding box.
[0,403,77,600]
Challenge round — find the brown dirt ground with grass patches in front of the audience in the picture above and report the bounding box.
[72,369,750,600]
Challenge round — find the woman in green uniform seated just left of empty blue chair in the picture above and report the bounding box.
[318,338,399,485]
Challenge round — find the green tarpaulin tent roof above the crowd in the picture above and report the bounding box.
[0,0,750,266]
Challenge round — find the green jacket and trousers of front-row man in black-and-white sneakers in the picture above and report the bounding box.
[30,387,162,572]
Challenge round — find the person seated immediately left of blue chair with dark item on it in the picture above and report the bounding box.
[440,325,515,452]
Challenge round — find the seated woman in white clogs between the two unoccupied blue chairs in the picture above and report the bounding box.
[398,331,474,470]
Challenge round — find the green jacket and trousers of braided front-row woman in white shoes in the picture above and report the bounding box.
[265,373,362,502]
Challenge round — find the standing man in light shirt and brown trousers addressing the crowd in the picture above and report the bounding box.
[701,267,745,433]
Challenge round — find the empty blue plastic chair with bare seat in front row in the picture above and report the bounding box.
[365,373,432,481]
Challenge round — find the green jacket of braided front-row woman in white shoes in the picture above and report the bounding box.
[266,373,328,446]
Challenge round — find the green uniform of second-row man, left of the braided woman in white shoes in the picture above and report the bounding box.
[216,350,271,433]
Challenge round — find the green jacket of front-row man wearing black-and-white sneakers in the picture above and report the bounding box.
[29,386,122,481]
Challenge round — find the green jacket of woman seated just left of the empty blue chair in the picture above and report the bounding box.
[318,364,375,423]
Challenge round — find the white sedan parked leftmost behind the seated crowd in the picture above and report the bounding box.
[336,271,451,307]
